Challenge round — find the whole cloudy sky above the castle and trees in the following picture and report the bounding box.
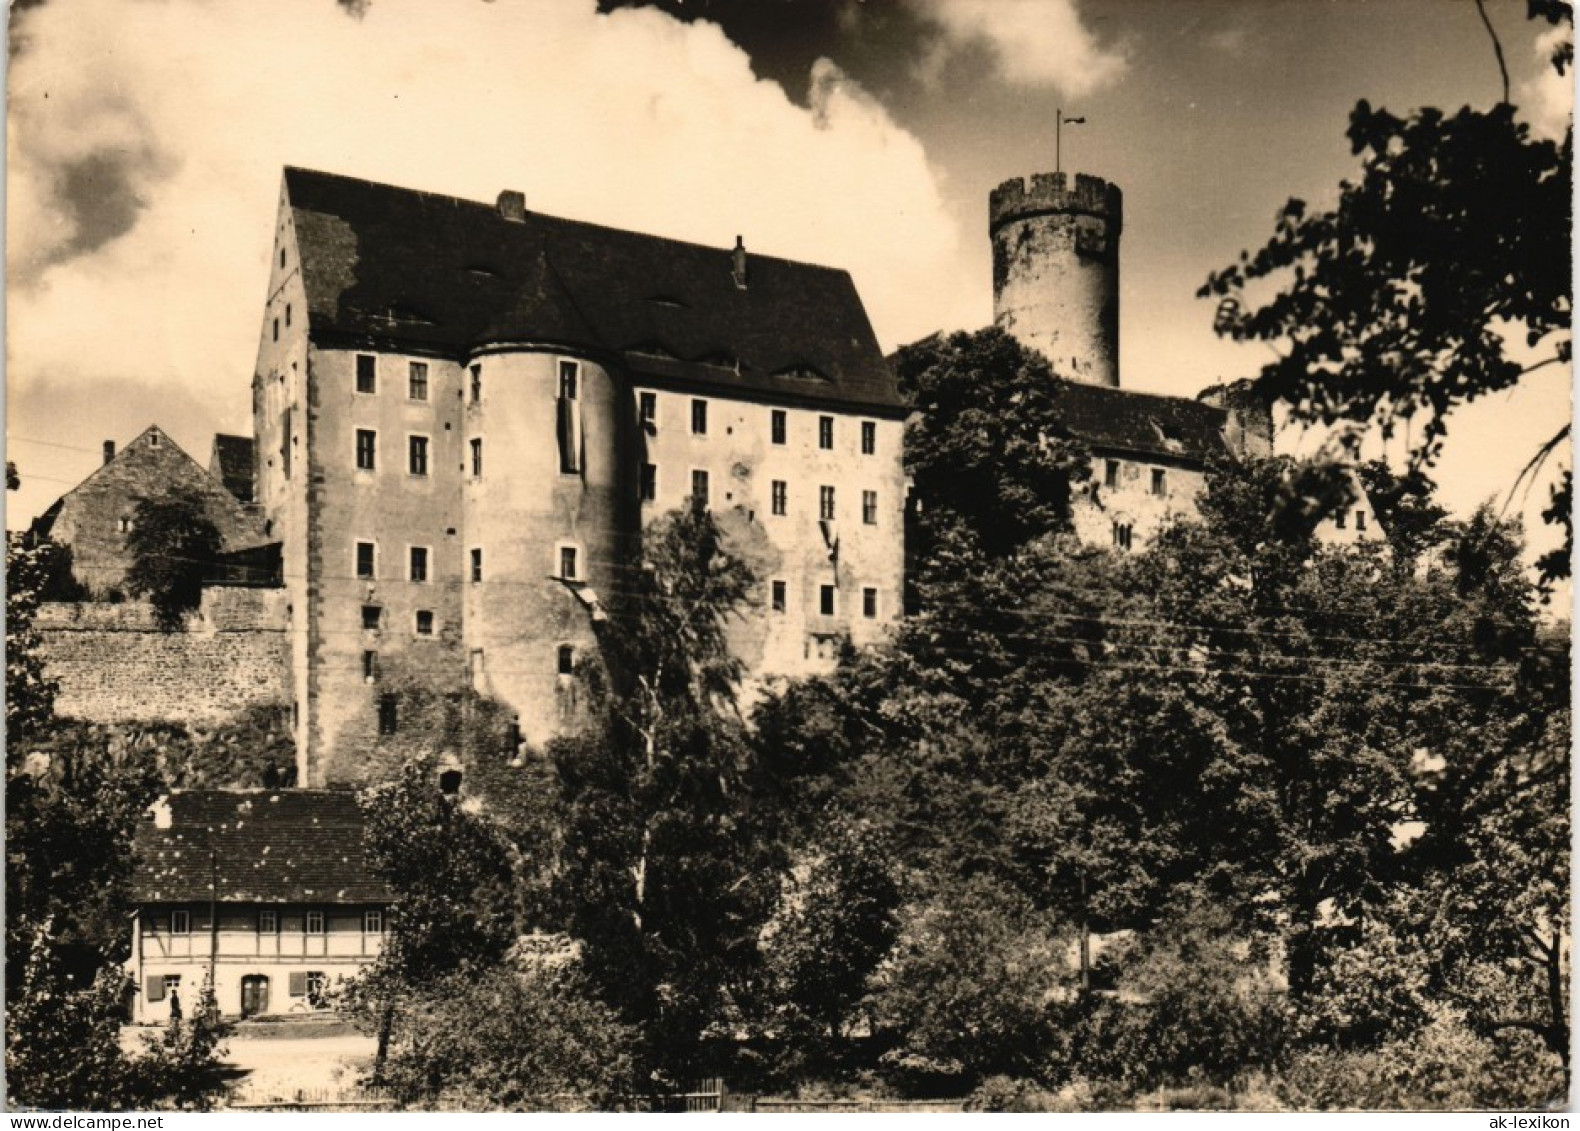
[6,0,1572,565]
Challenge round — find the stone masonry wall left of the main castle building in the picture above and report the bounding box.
[36,588,291,723]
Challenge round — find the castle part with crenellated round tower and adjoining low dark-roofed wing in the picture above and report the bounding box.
[988,172,1383,551]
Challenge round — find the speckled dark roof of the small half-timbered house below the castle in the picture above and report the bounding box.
[131,790,390,904]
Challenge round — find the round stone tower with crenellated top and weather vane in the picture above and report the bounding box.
[988,172,1123,387]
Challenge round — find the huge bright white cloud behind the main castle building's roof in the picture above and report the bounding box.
[6,0,959,521]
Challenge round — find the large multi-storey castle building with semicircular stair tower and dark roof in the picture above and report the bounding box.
[253,169,905,785]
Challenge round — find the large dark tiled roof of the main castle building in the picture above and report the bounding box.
[286,169,902,412]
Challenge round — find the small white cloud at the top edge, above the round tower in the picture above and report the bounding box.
[910,0,1127,96]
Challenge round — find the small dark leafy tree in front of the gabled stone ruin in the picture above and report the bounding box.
[126,487,224,630]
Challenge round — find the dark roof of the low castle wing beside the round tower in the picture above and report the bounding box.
[1055,381,1228,463]
